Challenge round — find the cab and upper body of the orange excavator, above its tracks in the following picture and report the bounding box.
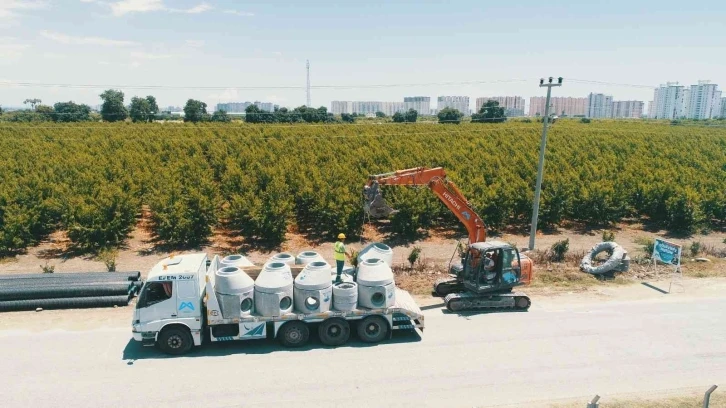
[461,241,524,294]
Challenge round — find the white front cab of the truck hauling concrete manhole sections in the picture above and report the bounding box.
[132,253,207,354]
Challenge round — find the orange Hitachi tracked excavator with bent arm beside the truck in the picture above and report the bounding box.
[363,167,533,312]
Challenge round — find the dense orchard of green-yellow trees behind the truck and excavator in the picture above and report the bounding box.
[0,119,726,256]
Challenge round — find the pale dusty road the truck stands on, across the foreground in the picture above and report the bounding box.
[0,296,726,408]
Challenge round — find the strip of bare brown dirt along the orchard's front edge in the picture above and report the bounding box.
[0,220,726,275]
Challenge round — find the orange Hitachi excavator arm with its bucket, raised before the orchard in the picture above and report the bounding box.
[364,167,487,244]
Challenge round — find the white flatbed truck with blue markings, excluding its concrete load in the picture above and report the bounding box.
[132,253,424,354]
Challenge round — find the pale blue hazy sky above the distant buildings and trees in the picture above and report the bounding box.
[0,0,726,107]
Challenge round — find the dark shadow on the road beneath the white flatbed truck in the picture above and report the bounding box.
[122,330,421,365]
